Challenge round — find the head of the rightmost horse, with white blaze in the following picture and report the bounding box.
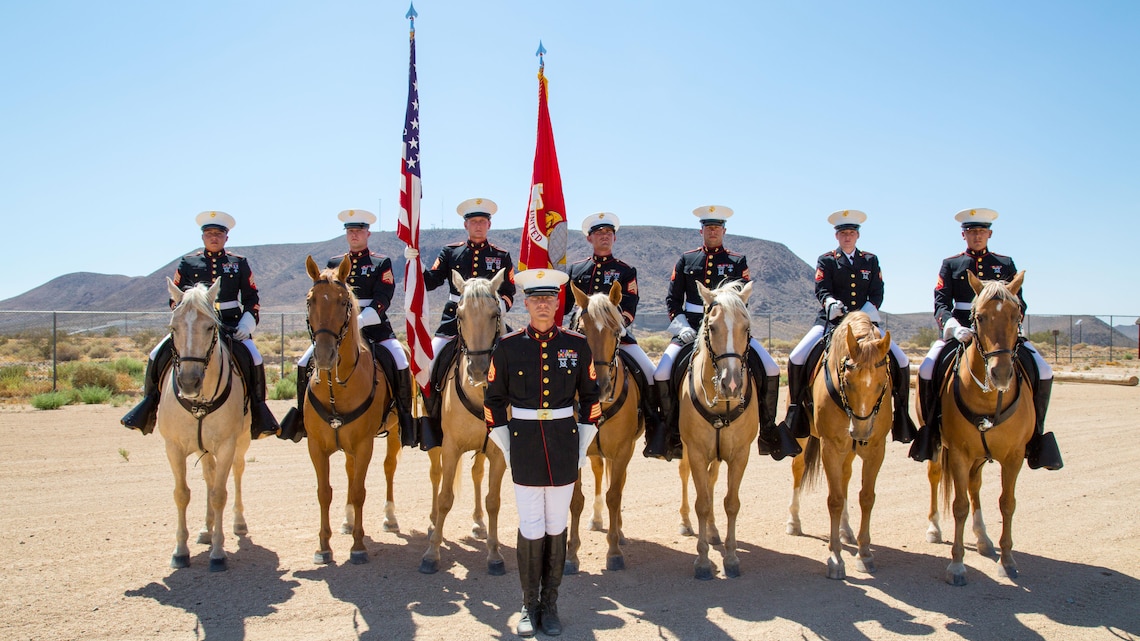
[967,270,1025,392]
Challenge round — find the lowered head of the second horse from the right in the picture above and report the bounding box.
[828,311,891,443]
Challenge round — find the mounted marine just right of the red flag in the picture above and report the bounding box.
[563,212,665,453]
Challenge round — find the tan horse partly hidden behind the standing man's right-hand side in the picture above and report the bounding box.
[565,281,644,574]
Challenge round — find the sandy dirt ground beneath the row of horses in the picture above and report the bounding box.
[0,374,1140,641]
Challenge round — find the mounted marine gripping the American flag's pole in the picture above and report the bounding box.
[404,198,515,449]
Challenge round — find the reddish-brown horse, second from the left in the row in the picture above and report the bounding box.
[304,255,399,563]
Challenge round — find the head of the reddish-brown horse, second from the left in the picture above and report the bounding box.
[304,254,360,372]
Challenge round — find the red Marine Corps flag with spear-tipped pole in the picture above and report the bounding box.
[519,42,568,324]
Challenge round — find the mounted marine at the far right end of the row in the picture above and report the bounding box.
[910,208,1064,470]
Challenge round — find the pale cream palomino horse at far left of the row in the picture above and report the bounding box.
[157,278,250,571]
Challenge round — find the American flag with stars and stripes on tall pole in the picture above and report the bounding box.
[396,5,432,390]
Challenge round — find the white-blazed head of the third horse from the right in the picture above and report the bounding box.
[693,281,752,400]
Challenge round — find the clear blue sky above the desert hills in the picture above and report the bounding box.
[0,0,1140,315]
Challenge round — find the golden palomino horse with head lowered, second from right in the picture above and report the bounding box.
[788,311,894,579]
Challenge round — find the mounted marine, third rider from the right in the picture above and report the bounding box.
[644,205,800,461]
